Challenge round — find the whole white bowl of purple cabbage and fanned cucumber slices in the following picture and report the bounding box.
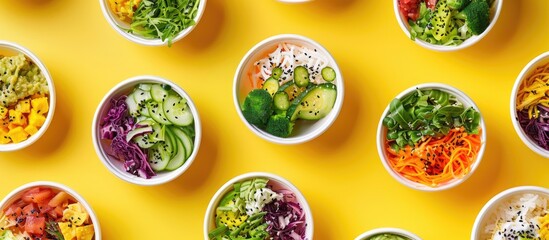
[92,76,202,185]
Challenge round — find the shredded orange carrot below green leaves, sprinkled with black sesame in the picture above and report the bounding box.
[385,128,481,187]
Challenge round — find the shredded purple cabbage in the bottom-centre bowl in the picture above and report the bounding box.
[263,190,307,240]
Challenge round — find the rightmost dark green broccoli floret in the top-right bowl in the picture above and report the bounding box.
[455,0,490,35]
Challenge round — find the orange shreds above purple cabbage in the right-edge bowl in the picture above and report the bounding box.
[516,63,549,118]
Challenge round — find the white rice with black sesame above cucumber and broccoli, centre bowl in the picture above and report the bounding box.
[252,43,328,88]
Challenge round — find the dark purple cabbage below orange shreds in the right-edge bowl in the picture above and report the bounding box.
[517,105,549,150]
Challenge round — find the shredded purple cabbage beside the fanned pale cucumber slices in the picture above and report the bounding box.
[101,96,156,179]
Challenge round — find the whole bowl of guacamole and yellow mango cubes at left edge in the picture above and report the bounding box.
[0,41,55,152]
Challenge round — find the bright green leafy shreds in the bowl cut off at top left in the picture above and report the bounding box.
[128,0,200,46]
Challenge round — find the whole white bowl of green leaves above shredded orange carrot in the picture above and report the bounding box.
[377,83,486,191]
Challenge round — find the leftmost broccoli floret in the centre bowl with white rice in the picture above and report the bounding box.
[242,89,273,128]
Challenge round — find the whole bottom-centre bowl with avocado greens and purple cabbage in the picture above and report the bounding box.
[204,172,313,240]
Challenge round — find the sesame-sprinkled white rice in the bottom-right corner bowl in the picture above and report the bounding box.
[480,193,549,240]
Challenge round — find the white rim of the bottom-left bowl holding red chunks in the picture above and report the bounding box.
[0,181,101,240]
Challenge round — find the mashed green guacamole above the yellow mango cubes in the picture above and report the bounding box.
[0,54,49,107]
